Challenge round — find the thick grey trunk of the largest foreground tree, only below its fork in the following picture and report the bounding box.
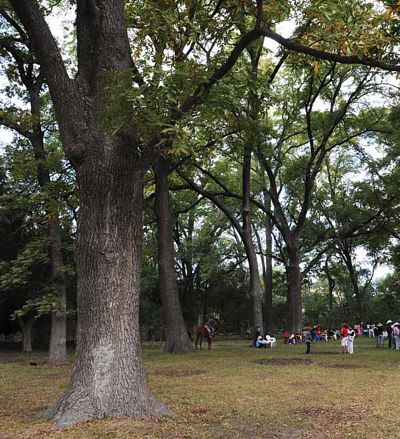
[45,146,167,426]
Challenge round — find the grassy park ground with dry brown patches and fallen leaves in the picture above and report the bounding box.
[0,338,400,439]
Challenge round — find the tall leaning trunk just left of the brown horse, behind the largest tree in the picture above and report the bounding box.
[155,158,194,354]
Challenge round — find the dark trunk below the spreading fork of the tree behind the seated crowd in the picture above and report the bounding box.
[288,237,303,333]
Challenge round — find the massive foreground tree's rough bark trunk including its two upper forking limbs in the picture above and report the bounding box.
[11,0,169,427]
